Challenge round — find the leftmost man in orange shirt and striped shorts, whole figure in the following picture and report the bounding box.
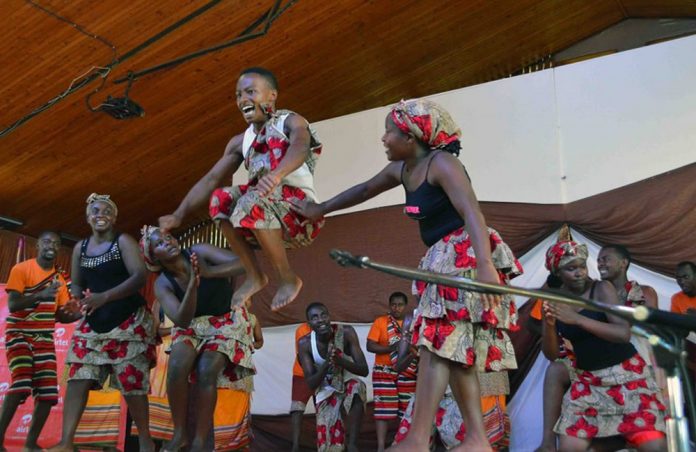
[0,231,81,450]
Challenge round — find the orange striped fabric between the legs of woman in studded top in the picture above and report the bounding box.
[75,389,122,450]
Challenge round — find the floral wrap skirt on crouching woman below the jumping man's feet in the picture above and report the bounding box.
[172,308,256,389]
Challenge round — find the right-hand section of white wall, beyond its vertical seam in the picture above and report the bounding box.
[555,36,696,201]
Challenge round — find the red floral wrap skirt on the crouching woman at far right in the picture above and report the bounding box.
[554,353,665,440]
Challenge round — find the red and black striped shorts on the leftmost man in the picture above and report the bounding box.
[5,331,58,404]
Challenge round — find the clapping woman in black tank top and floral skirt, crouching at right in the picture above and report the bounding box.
[543,241,666,451]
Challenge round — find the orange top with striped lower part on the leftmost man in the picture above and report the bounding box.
[5,259,70,333]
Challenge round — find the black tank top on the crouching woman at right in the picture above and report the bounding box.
[556,281,636,370]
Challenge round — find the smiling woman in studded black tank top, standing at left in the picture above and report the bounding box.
[58,193,155,450]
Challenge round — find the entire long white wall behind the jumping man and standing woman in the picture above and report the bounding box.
[302,36,696,213]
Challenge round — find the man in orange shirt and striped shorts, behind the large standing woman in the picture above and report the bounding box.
[367,292,416,452]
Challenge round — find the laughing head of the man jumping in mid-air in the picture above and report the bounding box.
[236,73,278,124]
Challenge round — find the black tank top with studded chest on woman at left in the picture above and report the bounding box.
[80,234,145,333]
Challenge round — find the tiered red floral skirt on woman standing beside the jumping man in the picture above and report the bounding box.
[413,228,522,372]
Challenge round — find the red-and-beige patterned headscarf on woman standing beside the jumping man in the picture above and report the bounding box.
[389,99,461,149]
